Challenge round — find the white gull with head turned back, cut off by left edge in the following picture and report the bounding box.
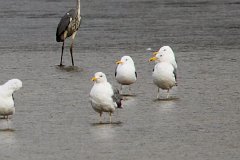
[0,79,22,127]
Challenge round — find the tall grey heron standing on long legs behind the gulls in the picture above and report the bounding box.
[56,0,81,66]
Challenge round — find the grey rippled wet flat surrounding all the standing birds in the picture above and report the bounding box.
[0,0,240,160]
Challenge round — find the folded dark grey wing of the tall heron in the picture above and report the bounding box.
[56,9,76,42]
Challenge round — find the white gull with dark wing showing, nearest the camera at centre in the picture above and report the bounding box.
[90,72,122,123]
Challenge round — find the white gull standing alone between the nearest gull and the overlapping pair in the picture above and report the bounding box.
[115,56,137,92]
